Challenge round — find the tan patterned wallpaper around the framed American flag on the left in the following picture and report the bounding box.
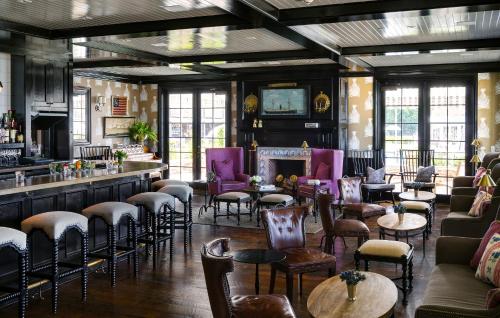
[73,77,158,157]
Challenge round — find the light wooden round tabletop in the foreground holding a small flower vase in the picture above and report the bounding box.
[307,272,398,318]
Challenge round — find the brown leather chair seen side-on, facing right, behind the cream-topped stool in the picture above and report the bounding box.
[318,194,370,255]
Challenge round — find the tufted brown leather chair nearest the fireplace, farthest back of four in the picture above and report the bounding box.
[337,177,385,221]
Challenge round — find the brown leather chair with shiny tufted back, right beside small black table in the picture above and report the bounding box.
[261,206,336,301]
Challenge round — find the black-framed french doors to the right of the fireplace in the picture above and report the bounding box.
[381,80,475,194]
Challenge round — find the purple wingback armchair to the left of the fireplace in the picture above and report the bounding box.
[206,147,250,196]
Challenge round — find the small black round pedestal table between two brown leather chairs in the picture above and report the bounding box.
[228,249,286,295]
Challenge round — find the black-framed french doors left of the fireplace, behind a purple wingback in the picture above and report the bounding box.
[165,89,228,181]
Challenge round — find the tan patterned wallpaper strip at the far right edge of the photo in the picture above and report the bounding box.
[477,73,500,156]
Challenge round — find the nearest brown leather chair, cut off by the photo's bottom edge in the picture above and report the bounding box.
[201,238,296,318]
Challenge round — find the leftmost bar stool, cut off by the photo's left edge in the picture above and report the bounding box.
[0,226,28,318]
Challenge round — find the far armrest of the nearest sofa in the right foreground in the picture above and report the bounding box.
[436,236,481,265]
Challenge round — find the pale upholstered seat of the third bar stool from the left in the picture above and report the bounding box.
[82,202,138,225]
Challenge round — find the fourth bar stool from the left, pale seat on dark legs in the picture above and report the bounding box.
[127,192,175,268]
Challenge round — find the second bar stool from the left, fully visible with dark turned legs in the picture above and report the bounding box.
[21,211,88,314]
